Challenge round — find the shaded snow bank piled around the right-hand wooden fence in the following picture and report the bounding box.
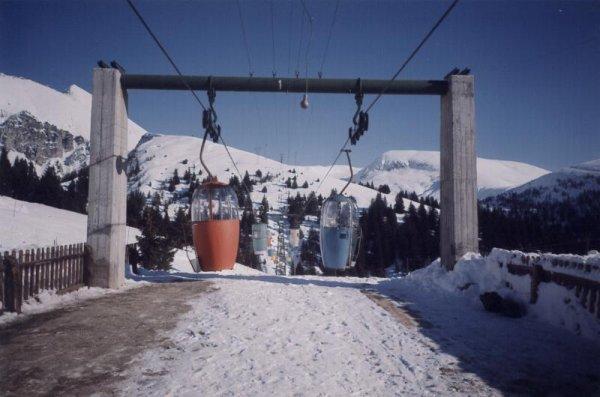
[402,249,600,341]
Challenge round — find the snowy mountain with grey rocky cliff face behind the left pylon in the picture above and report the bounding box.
[0,73,146,172]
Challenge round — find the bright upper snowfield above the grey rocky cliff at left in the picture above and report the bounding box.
[0,73,146,150]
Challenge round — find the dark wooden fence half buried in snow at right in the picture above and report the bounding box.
[496,252,600,319]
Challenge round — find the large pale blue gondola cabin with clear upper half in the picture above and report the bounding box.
[320,194,360,270]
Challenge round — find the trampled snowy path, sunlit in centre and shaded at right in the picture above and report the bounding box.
[119,268,600,396]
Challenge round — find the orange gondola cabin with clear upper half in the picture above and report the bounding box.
[192,178,240,271]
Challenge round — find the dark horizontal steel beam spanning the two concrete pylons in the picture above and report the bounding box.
[121,74,448,95]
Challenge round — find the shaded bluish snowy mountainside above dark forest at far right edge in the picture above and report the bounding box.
[492,159,600,202]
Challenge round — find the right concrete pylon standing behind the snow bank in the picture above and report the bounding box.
[440,75,479,270]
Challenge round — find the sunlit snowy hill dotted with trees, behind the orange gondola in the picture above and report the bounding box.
[128,134,404,208]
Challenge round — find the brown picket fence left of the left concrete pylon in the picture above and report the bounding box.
[0,244,90,313]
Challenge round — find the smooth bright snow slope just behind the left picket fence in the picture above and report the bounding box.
[0,196,139,252]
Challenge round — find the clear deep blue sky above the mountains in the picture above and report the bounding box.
[0,0,600,169]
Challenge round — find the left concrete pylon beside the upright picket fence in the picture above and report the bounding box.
[87,68,128,289]
